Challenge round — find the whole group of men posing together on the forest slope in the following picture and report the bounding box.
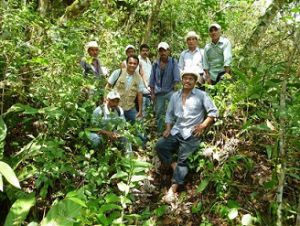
[81,23,232,202]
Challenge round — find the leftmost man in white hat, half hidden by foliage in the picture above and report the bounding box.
[80,41,103,78]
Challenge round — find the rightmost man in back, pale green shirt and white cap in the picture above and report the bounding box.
[203,24,232,85]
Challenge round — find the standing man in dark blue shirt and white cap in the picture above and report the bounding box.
[150,42,180,133]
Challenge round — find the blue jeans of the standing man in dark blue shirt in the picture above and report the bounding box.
[154,91,174,133]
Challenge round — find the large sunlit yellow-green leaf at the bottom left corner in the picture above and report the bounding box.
[4,193,35,226]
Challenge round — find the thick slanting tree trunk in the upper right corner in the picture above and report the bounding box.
[242,0,289,56]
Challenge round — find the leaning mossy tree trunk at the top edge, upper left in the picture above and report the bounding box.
[58,0,91,24]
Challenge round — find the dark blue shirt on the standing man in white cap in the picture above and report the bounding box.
[150,57,180,94]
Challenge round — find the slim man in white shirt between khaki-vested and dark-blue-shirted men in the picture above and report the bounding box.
[139,44,152,116]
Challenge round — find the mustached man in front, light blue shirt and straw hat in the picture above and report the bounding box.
[155,71,218,202]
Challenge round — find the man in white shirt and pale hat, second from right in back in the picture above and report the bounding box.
[178,31,204,83]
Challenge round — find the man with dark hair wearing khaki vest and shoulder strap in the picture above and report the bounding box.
[106,55,144,123]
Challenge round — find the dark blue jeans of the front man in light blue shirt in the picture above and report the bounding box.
[155,133,200,184]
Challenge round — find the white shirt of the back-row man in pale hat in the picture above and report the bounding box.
[178,48,203,74]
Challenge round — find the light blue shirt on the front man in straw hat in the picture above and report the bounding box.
[165,89,218,139]
